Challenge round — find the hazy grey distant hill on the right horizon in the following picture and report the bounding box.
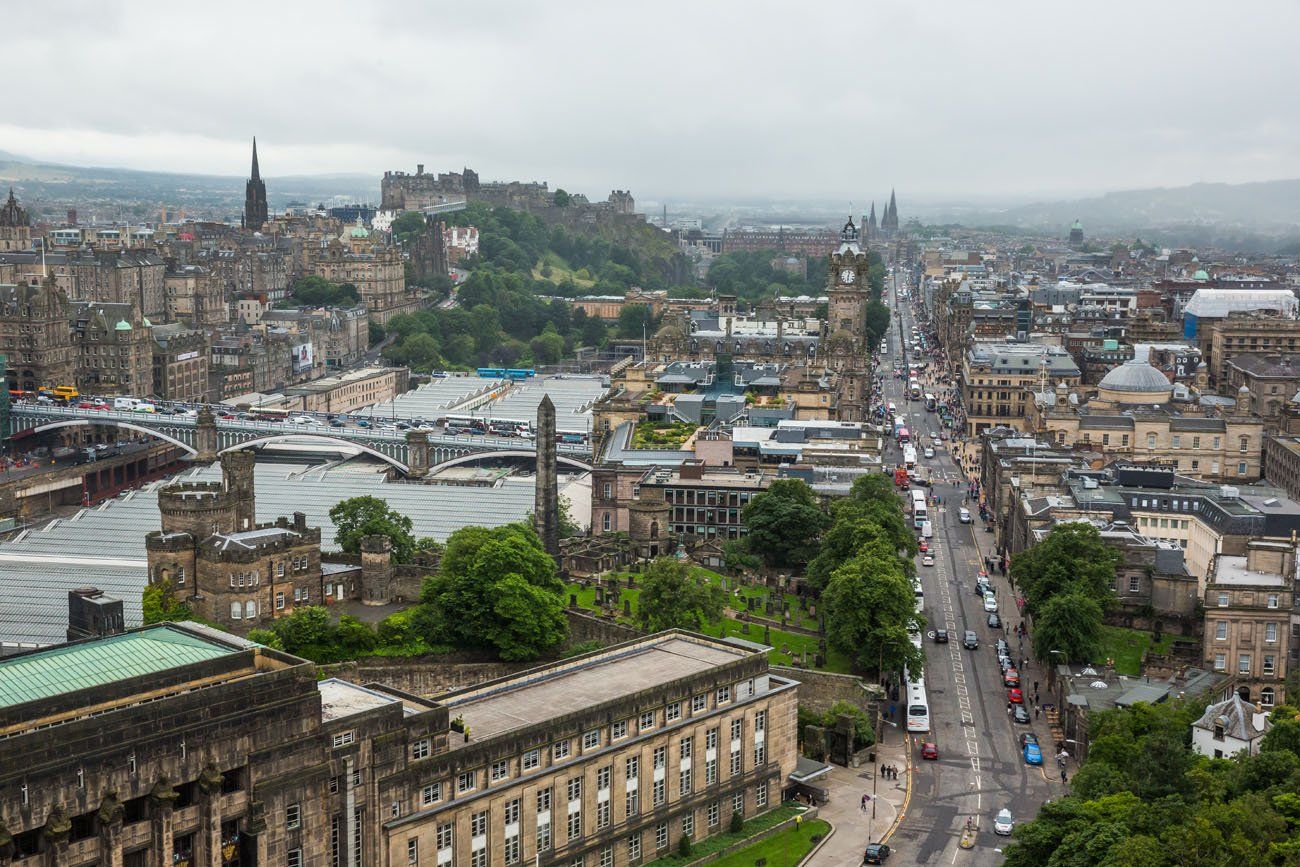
[980,179,1300,234]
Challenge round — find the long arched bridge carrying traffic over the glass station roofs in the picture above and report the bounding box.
[9,403,592,478]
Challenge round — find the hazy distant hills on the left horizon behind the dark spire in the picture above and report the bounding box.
[0,152,380,216]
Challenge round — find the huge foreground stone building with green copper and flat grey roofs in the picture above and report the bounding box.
[0,624,798,867]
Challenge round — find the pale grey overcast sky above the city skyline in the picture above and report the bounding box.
[0,0,1300,203]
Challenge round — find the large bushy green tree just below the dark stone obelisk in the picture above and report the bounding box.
[421,524,568,660]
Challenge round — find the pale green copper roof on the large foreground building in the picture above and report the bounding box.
[0,627,238,707]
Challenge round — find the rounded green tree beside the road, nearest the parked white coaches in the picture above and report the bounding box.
[822,552,926,673]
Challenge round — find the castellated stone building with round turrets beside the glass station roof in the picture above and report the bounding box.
[146,451,393,633]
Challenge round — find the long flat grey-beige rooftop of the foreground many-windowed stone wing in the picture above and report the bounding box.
[441,636,761,749]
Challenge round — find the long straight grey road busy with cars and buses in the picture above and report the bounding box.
[880,273,1061,864]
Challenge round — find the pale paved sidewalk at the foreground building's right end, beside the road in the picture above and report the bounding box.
[807,725,911,867]
